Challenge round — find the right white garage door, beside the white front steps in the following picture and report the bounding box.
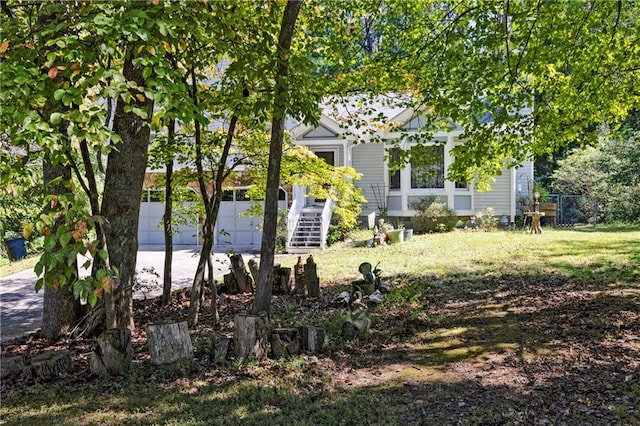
[216,189,287,245]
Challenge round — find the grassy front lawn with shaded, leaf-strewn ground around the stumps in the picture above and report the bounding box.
[0,226,640,425]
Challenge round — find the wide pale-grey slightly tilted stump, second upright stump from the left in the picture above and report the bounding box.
[145,322,192,365]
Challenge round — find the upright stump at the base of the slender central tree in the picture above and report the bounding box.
[233,315,270,360]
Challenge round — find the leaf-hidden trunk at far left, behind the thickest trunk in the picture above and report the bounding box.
[42,157,82,339]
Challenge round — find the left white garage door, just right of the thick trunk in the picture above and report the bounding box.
[138,190,198,245]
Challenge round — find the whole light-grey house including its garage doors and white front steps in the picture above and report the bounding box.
[138,97,533,253]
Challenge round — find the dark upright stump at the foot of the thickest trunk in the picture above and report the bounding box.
[89,328,133,376]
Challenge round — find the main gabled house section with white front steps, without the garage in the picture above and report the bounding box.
[288,102,533,252]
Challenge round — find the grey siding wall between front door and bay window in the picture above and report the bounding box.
[351,143,388,214]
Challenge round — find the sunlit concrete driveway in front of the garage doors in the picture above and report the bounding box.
[0,246,258,343]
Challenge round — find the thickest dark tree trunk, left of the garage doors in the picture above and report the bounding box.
[102,52,153,329]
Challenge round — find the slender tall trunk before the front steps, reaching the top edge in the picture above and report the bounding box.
[253,0,302,315]
